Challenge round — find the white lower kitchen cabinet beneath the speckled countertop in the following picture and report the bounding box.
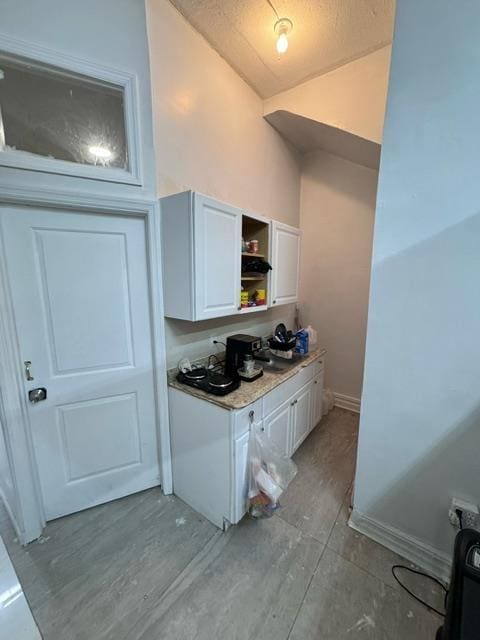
[169,358,323,528]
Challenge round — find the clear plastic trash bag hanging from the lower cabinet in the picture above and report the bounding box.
[248,427,297,518]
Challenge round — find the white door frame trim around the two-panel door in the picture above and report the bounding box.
[0,185,172,544]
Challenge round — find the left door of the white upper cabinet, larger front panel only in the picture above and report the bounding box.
[194,194,242,320]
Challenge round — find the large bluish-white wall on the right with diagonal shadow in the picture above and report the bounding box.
[355,0,480,568]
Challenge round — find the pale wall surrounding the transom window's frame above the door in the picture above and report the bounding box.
[0,0,155,197]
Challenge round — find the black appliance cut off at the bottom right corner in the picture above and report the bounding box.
[436,529,480,640]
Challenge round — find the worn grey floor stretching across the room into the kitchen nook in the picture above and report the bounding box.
[0,409,441,640]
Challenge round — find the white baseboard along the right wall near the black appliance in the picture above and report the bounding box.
[348,510,451,582]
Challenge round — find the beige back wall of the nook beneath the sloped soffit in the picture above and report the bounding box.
[300,151,378,398]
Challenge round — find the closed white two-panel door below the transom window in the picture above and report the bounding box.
[0,208,159,520]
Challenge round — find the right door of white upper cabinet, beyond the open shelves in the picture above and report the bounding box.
[271,221,300,306]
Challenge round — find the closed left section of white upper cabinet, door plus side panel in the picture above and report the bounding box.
[161,191,242,320]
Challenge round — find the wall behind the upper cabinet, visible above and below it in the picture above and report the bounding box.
[147,0,300,366]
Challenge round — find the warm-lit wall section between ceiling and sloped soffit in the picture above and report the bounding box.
[264,46,391,143]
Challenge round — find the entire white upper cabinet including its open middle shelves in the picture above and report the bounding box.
[161,191,300,321]
